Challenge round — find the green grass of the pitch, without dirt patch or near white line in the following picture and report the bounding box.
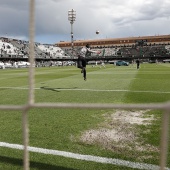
[0,64,170,170]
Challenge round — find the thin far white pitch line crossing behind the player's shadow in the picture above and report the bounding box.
[0,87,170,94]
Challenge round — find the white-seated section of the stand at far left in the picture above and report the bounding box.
[0,38,70,59]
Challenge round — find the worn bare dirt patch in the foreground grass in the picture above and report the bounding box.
[80,110,158,156]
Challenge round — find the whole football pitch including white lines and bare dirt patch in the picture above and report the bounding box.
[0,63,170,170]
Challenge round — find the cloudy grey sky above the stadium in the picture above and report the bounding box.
[0,0,170,44]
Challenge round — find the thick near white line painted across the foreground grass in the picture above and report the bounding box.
[0,142,170,170]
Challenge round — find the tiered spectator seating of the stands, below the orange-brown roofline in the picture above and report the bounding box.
[0,37,170,67]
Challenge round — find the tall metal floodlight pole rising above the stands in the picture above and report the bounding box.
[68,9,76,57]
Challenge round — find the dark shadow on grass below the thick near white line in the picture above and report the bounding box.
[0,156,75,170]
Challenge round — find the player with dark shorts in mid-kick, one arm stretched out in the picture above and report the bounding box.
[77,44,101,80]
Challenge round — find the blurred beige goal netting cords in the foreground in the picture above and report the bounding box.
[0,0,170,170]
